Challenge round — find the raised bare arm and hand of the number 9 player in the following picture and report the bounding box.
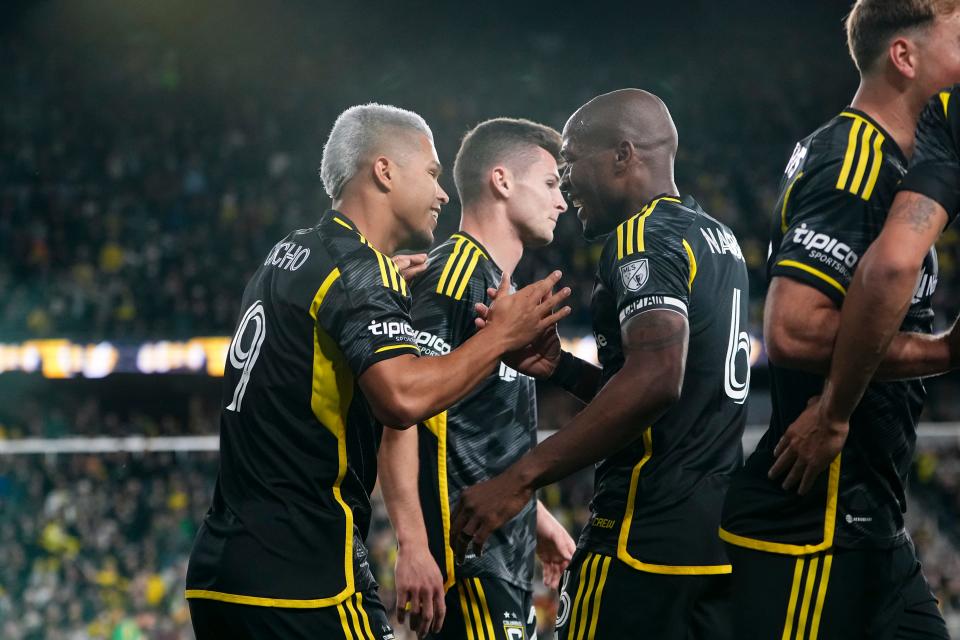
[359,271,570,429]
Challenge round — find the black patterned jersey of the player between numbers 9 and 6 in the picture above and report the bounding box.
[412,231,537,589]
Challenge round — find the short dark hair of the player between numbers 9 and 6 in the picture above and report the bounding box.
[453,118,561,205]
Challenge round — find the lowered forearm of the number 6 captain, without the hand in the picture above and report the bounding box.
[510,368,676,489]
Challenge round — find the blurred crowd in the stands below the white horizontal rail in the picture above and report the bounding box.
[0,447,960,640]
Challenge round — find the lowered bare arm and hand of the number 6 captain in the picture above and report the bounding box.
[450,310,690,560]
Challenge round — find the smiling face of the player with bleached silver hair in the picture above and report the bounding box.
[390,133,450,249]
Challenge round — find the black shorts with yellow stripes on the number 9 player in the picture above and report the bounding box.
[189,589,394,640]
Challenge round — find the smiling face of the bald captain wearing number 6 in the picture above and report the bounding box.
[560,113,620,239]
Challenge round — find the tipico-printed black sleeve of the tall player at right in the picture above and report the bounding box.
[769,160,882,306]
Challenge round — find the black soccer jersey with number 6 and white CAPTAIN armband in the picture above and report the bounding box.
[579,197,750,575]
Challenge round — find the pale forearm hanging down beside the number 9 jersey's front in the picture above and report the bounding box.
[378,428,427,547]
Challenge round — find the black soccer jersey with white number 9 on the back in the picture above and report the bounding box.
[187,211,419,608]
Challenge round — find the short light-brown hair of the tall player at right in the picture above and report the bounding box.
[846,0,960,75]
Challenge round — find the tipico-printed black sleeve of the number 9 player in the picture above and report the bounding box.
[317,256,420,378]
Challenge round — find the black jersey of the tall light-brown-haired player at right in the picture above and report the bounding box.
[721,109,937,555]
